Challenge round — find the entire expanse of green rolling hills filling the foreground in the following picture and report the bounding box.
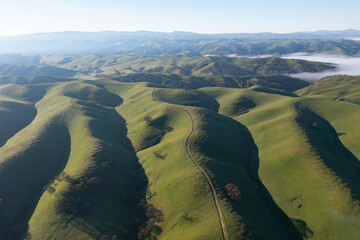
[0,62,360,240]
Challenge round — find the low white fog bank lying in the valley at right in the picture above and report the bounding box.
[281,53,360,81]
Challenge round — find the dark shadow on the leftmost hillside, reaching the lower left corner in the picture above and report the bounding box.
[0,124,70,240]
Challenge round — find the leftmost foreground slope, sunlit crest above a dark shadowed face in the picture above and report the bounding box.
[0,84,69,239]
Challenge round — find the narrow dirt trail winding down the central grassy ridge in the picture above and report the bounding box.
[152,89,229,240]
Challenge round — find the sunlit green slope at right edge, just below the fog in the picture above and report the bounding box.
[296,76,360,159]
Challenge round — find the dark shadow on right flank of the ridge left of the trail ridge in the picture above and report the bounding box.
[49,100,148,239]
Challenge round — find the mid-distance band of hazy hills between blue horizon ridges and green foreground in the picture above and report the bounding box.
[0,54,334,78]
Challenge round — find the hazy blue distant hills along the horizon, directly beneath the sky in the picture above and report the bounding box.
[0,30,360,56]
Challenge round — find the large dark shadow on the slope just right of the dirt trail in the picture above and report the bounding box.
[190,110,301,239]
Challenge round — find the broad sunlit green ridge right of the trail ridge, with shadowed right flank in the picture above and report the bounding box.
[208,86,360,239]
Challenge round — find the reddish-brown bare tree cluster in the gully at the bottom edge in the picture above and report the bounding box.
[138,199,164,240]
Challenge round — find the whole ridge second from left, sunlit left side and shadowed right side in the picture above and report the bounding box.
[28,83,147,239]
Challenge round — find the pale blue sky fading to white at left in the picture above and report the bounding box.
[0,0,360,36]
